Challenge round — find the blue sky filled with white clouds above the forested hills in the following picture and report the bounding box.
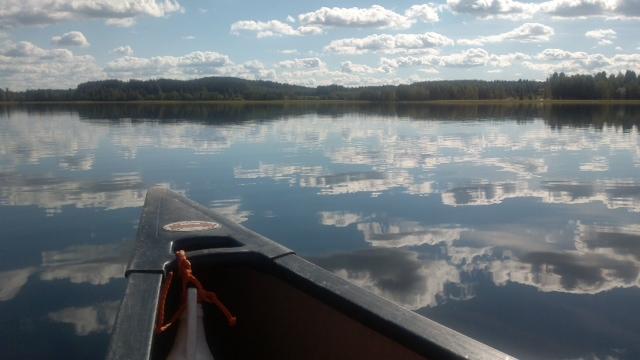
[0,0,640,90]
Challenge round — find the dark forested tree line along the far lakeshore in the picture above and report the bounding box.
[0,71,640,101]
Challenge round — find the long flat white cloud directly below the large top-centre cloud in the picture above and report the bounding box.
[325,32,454,54]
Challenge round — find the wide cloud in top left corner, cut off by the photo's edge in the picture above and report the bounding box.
[0,0,183,28]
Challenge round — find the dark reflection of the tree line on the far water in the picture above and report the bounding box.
[0,102,640,130]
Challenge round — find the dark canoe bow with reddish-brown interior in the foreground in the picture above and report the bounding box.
[107,187,513,360]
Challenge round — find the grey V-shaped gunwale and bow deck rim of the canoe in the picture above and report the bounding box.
[107,187,513,360]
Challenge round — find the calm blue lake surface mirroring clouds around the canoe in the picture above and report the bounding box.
[0,105,640,359]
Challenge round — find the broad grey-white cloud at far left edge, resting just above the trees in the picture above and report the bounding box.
[0,41,106,90]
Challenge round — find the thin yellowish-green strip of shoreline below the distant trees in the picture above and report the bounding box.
[0,99,640,105]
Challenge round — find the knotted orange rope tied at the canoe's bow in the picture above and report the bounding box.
[156,250,237,333]
